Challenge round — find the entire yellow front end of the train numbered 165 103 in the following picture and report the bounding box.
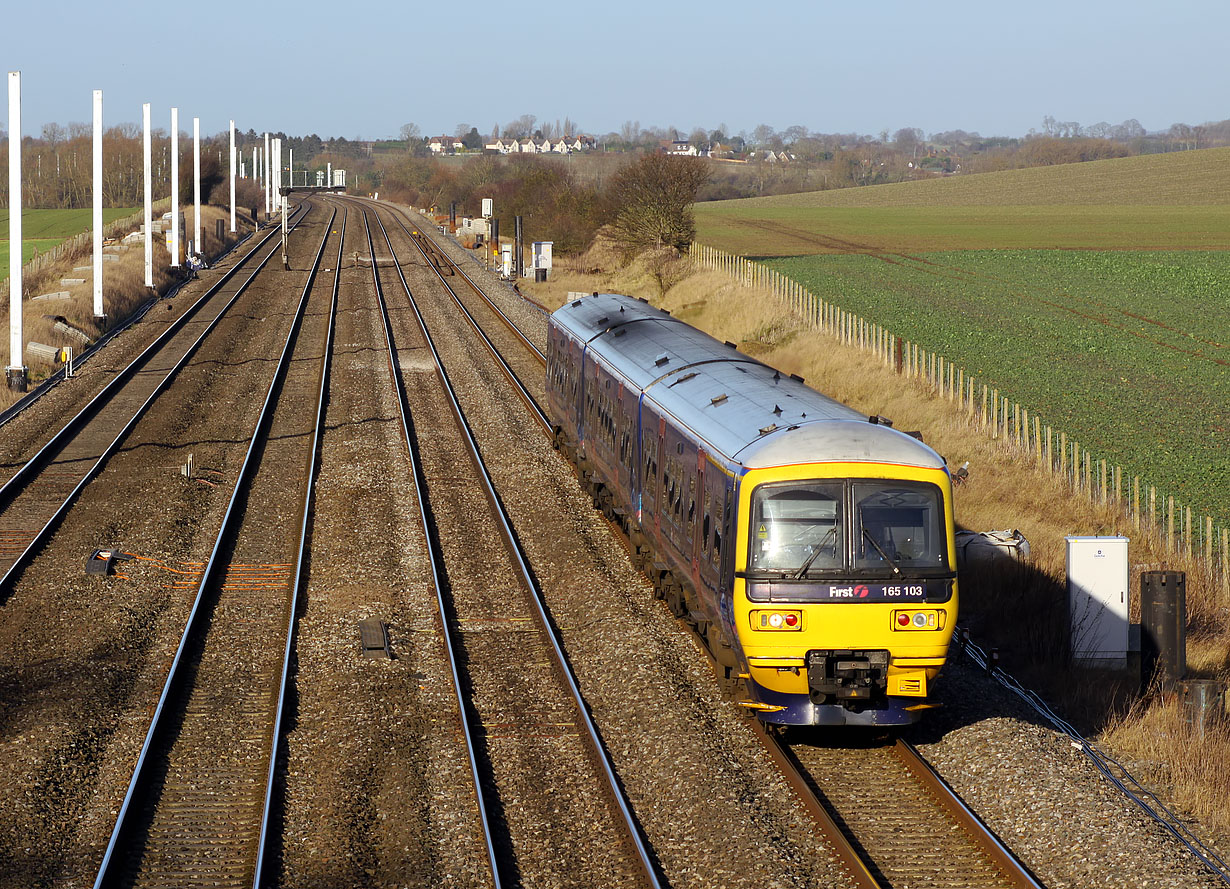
[732,462,957,725]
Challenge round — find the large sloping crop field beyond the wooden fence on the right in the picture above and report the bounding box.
[696,150,1230,523]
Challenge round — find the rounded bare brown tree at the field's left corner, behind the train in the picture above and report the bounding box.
[609,154,710,255]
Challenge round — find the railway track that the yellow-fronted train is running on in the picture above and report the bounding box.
[383,200,1041,889]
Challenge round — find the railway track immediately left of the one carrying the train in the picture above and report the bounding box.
[364,202,659,887]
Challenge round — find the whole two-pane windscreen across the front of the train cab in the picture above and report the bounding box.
[748,480,950,580]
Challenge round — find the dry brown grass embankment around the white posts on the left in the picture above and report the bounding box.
[0,205,252,409]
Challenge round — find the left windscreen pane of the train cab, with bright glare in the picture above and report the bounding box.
[748,482,845,578]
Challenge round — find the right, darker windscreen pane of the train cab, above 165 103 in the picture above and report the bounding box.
[854,481,948,569]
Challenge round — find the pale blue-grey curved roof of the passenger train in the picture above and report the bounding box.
[551,294,945,477]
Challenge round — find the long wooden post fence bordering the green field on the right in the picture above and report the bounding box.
[689,242,1230,594]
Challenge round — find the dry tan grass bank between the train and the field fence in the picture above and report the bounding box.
[523,247,1230,831]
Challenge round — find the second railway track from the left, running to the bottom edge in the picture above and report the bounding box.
[95,205,344,889]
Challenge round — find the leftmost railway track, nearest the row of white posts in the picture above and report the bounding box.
[0,201,306,604]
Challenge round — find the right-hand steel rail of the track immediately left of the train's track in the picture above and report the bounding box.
[364,206,662,889]
